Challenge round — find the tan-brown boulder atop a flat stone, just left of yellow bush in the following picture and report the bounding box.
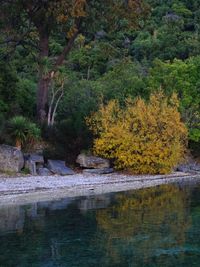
[76,154,110,169]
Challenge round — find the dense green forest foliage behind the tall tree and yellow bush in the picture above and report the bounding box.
[0,0,200,163]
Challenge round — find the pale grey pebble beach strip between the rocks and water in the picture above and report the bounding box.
[0,172,200,206]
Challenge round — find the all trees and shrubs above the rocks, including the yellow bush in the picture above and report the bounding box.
[0,0,200,173]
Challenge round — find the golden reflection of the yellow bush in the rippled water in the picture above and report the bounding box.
[96,185,190,266]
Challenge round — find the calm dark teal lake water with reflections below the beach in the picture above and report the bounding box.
[0,183,200,267]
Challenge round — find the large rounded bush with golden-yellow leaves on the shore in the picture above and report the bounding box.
[87,92,187,174]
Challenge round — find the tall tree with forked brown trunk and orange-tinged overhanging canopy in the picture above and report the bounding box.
[0,0,147,122]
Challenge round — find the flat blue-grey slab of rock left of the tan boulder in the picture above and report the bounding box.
[47,159,75,175]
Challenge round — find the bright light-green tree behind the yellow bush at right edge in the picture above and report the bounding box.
[148,57,200,142]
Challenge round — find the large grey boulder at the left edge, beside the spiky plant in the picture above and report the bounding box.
[0,145,24,172]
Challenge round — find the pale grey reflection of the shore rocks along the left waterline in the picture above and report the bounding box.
[0,195,110,235]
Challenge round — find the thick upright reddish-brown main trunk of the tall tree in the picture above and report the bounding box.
[37,33,50,122]
